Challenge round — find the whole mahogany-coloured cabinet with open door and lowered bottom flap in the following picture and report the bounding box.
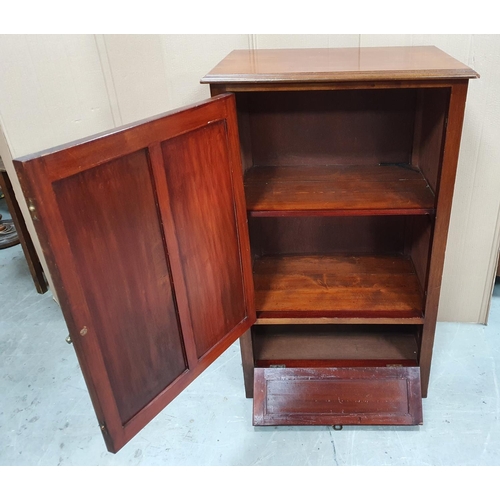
[15,47,478,452]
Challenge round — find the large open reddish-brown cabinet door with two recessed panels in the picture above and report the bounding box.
[14,95,255,452]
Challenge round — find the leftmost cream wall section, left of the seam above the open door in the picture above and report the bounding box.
[0,35,114,289]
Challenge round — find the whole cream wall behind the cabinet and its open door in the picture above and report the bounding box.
[0,34,500,322]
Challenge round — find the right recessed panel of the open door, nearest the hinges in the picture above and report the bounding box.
[162,120,248,357]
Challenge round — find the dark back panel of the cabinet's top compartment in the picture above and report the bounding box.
[245,89,416,166]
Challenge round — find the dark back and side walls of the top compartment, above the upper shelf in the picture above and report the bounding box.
[236,88,450,181]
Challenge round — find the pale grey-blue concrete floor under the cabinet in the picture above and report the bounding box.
[0,194,500,465]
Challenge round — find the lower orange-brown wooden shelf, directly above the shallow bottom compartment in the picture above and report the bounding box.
[253,255,423,324]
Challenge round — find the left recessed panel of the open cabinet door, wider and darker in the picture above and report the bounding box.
[53,150,186,423]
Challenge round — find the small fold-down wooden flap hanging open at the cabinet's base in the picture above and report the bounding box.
[254,367,422,425]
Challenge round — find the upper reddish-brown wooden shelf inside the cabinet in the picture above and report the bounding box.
[245,165,435,217]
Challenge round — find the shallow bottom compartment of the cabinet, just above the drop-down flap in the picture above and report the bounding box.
[252,325,420,368]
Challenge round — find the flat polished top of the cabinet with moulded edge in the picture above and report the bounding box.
[201,46,479,84]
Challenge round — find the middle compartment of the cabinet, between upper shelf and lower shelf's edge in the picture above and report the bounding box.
[249,216,432,323]
